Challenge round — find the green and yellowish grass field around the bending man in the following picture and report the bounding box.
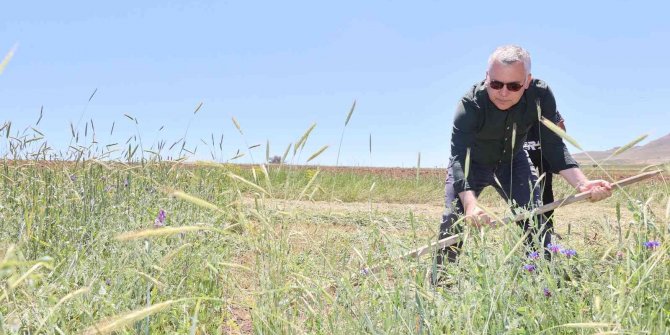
[0,161,670,334]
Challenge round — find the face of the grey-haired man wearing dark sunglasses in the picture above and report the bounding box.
[486,62,531,110]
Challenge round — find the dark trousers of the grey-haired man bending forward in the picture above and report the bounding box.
[436,150,551,265]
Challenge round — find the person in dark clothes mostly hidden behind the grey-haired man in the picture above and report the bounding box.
[523,110,565,242]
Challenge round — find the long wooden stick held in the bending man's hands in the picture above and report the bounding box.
[362,170,662,274]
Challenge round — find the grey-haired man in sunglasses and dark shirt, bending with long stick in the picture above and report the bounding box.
[434,45,612,268]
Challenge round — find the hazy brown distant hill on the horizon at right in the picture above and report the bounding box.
[572,134,670,165]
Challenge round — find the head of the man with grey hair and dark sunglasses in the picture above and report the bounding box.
[486,45,531,110]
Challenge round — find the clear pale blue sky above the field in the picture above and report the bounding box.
[0,1,670,167]
